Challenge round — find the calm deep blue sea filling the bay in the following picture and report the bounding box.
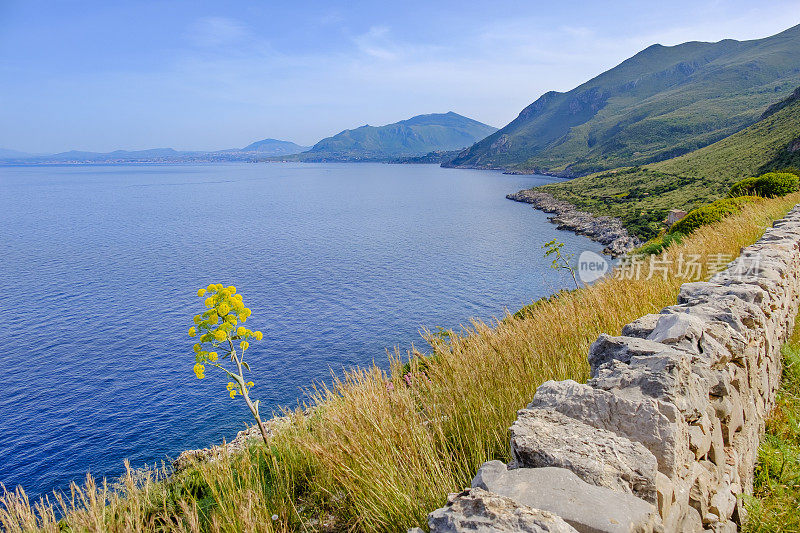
[0,163,602,497]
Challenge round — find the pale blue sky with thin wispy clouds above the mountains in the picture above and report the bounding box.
[0,0,800,152]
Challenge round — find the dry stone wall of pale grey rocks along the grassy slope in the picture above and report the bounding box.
[418,206,800,533]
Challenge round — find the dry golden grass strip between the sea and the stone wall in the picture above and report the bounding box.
[6,193,800,532]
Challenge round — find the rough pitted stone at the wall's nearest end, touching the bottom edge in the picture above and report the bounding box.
[428,488,576,533]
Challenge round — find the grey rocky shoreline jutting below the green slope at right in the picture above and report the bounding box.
[506,189,642,257]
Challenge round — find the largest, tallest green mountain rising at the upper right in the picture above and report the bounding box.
[448,26,800,176]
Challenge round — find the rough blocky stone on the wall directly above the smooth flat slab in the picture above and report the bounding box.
[510,409,658,504]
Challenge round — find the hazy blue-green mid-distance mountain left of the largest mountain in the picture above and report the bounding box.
[295,111,497,161]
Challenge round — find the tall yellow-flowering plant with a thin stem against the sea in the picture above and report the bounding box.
[189,283,267,443]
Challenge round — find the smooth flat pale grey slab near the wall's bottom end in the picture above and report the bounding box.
[472,461,661,533]
